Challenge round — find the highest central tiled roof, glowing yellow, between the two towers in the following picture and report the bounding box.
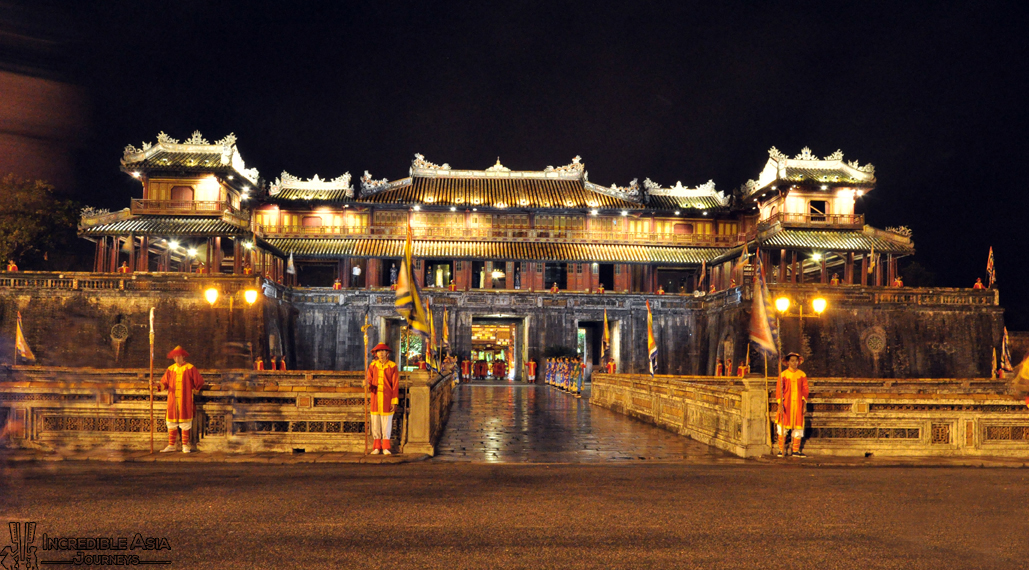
[359,176,643,210]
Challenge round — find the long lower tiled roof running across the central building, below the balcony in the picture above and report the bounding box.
[268,238,724,264]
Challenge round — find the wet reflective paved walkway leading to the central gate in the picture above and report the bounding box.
[432,383,743,463]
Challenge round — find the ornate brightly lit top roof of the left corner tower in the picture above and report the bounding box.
[121,131,260,185]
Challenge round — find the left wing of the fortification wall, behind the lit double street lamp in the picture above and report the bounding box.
[0,273,295,369]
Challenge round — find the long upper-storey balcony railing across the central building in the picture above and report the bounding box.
[258,225,753,247]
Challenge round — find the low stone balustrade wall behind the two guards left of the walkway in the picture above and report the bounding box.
[0,366,444,455]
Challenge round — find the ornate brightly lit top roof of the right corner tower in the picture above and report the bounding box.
[744,146,876,197]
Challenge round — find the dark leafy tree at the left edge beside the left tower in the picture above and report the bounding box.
[0,174,78,262]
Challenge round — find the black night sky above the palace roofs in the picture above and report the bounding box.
[16,1,1029,323]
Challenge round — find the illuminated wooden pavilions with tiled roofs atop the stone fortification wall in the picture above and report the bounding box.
[80,133,914,288]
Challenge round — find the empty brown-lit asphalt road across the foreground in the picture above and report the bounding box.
[0,461,1029,569]
